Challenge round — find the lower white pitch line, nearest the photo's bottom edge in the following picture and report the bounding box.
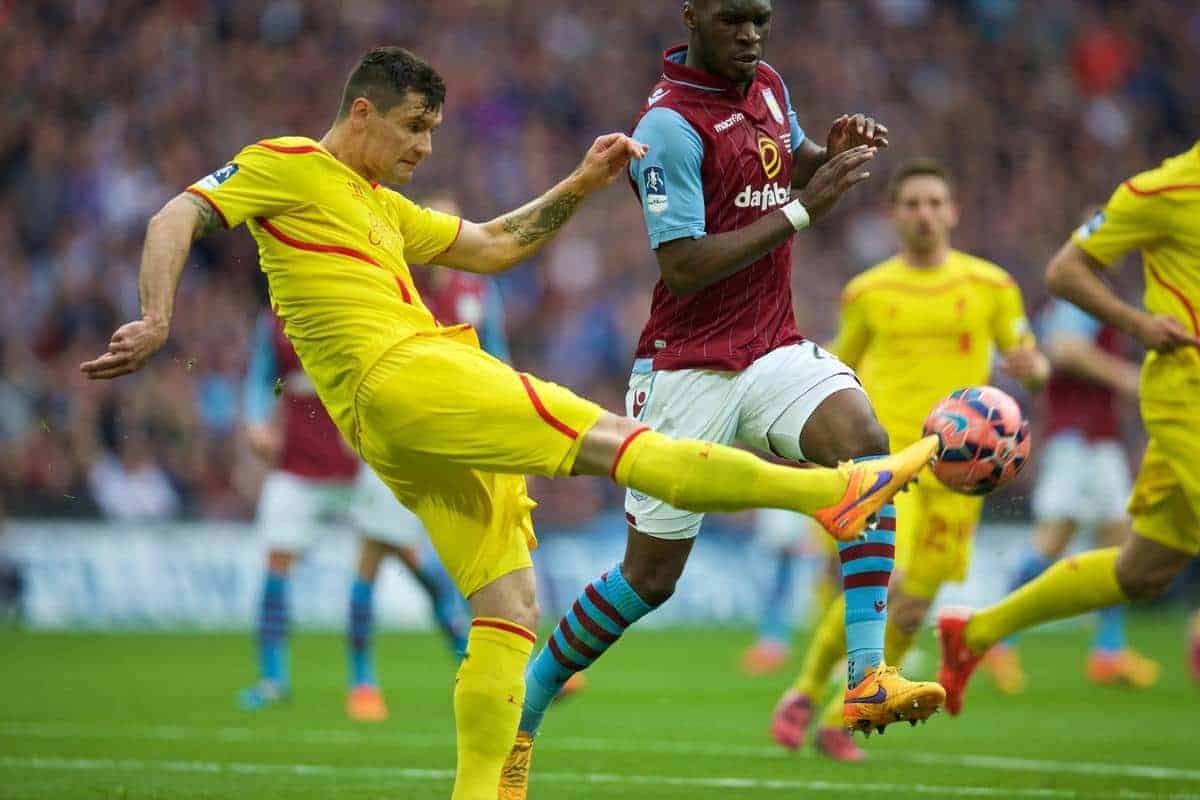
[0,757,1180,800]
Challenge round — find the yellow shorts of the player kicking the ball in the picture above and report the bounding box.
[354,330,605,596]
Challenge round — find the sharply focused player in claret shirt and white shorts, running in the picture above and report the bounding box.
[510,0,942,798]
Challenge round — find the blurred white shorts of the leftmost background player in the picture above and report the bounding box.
[257,470,354,553]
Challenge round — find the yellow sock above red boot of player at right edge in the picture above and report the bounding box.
[964,547,1129,652]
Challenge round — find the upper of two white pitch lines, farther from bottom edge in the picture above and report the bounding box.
[0,722,1200,781]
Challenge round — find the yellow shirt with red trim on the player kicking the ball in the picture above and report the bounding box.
[187,137,460,435]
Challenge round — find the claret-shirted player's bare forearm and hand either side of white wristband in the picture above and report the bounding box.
[654,145,875,296]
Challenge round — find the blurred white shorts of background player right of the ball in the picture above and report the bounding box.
[1033,431,1132,525]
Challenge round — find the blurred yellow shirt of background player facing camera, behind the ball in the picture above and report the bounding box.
[830,251,1033,450]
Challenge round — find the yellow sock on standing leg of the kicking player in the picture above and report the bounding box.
[452,616,536,800]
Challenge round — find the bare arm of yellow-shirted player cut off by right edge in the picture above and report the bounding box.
[1046,241,1200,353]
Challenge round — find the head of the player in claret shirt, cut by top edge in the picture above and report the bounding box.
[684,0,772,84]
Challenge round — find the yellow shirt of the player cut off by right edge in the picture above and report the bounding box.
[1072,142,1200,405]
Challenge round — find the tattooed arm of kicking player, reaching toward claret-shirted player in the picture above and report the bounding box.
[436,133,646,272]
